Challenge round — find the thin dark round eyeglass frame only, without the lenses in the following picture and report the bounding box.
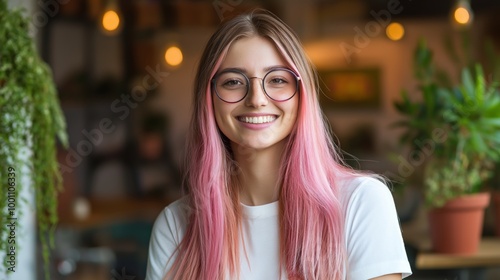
[211,67,302,104]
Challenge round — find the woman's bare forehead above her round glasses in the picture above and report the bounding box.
[219,36,286,72]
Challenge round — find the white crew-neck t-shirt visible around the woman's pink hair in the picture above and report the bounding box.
[146,177,411,280]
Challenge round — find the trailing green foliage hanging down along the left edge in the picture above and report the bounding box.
[0,0,67,279]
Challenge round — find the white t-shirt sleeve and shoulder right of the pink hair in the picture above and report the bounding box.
[338,177,411,279]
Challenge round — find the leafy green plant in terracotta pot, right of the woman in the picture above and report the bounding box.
[395,40,500,254]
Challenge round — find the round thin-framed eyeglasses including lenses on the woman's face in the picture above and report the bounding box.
[212,68,300,103]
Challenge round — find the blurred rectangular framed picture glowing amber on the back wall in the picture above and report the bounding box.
[318,68,381,109]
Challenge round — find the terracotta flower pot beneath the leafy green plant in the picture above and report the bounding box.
[429,193,490,255]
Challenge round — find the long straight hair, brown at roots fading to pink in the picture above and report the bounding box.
[167,10,356,280]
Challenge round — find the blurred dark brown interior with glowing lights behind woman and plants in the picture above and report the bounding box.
[9,0,500,279]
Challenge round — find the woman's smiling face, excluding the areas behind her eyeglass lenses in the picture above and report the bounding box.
[212,36,299,153]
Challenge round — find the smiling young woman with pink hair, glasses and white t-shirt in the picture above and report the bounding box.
[146,10,411,280]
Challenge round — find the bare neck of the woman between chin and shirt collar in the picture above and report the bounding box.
[233,141,286,205]
